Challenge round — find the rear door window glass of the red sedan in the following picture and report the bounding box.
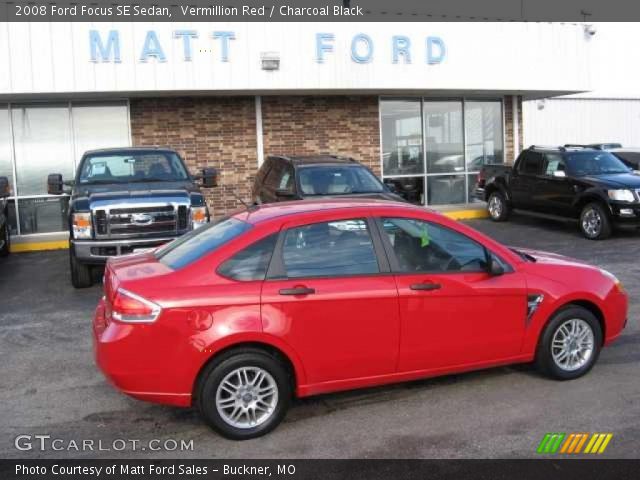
[282,219,380,278]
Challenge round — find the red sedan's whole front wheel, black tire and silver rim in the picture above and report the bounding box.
[536,306,602,380]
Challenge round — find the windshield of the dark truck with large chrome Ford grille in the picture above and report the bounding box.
[79,151,189,184]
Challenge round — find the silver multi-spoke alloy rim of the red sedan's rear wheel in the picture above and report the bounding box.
[216,367,278,429]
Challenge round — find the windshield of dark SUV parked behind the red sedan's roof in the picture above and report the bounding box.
[299,165,384,195]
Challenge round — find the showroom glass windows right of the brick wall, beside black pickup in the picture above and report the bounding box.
[380,98,504,205]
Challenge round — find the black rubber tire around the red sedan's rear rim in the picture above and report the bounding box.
[196,348,293,440]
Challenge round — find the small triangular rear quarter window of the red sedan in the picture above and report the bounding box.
[218,233,278,281]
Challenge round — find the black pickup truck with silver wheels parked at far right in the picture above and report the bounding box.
[476,146,640,240]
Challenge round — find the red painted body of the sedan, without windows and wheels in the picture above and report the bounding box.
[94,200,627,406]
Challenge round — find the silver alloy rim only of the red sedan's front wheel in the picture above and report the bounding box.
[551,318,595,372]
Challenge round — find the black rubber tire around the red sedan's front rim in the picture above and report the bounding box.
[536,305,602,380]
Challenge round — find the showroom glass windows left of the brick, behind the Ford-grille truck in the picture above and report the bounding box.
[0,102,131,235]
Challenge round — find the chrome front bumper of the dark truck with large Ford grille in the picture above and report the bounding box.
[71,237,177,264]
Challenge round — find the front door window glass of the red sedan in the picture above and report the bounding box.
[383,218,487,273]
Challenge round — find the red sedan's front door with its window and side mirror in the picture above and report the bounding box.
[378,218,527,372]
